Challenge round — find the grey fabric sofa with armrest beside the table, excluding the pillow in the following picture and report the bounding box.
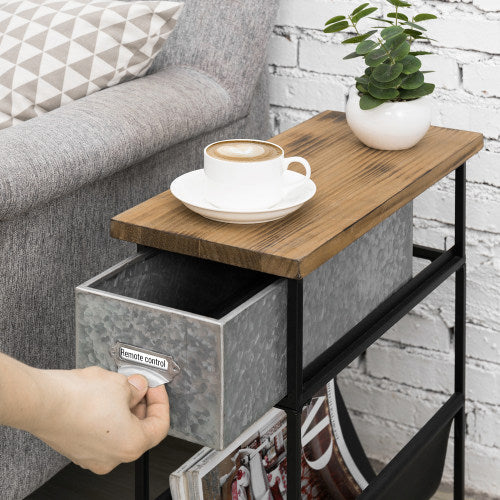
[0,0,277,500]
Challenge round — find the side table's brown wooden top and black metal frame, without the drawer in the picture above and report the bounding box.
[111,111,483,500]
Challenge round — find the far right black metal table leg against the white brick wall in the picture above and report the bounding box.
[453,164,466,500]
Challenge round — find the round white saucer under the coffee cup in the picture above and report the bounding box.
[170,169,316,224]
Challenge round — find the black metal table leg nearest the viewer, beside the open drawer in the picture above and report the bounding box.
[283,279,303,500]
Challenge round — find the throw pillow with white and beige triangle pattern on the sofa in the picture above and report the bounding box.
[0,0,183,129]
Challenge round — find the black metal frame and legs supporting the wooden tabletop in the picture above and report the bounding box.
[136,163,466,500]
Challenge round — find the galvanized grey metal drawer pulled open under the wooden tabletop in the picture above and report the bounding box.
[76,205,412,449]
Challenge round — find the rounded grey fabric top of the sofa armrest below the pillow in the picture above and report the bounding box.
[0,67,235,220]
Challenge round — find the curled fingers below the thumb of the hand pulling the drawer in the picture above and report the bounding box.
[141,385,170,448]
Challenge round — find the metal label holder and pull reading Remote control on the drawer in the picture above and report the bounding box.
[110,342,181,387]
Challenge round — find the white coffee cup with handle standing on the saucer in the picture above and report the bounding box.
[204,139,311,211]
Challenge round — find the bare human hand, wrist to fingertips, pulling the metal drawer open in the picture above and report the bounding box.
[26,366,170,474]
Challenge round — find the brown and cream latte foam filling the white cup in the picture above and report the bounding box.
[207,141,281,162]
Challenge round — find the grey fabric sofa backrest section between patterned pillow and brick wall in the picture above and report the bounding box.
[152,0,278,106]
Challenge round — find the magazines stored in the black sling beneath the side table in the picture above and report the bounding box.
[182,380,374,500]
